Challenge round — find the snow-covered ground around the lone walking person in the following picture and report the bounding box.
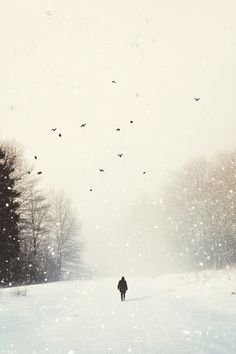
[0,272,236,354]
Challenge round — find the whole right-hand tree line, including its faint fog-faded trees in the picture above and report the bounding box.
[122,151,236,274]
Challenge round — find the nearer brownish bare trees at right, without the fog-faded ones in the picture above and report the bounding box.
[160,151,236,269]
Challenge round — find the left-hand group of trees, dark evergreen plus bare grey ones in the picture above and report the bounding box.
[0,143,82,285]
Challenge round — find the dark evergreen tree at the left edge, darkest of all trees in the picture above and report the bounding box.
[0,146,20,285]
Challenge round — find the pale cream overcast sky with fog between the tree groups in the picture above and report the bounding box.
[0,0,236,271]
